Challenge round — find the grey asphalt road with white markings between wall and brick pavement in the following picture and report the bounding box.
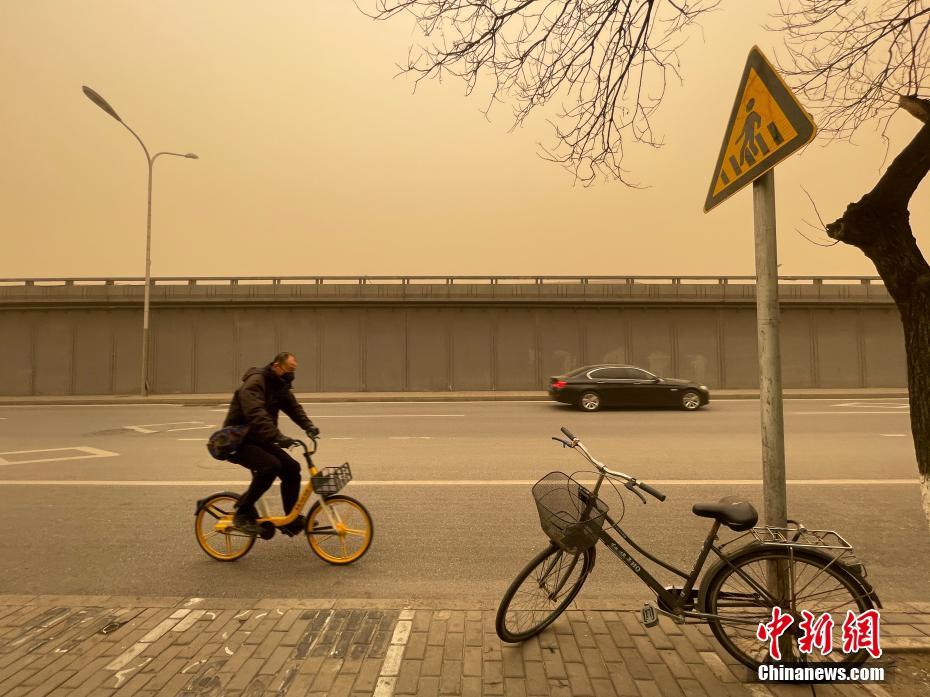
[0,399,930,603]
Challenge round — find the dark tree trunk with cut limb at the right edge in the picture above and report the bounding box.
[827,117,930,526]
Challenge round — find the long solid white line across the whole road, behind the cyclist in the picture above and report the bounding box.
[0,479,918,487]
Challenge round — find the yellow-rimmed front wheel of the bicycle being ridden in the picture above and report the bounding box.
[306,494,375,565]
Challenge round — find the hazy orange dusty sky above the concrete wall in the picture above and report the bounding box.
[0,0,930,278]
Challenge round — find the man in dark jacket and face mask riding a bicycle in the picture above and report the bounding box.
[223,351,320,535]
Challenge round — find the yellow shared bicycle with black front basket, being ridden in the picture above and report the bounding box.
[194,439,374,564]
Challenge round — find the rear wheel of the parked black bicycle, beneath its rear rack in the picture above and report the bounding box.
[702,547,874,670]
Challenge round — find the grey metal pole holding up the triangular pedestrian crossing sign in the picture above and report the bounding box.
[752,169,788,528]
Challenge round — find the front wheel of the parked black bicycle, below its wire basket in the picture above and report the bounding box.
[495,544,594,643]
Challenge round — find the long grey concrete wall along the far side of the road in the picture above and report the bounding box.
[0,284,906,395]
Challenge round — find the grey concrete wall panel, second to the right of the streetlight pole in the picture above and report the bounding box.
[193,308,241,392]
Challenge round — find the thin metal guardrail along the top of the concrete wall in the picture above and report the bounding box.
[0,276,882,287]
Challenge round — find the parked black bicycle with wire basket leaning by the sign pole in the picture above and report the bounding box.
[496,428,881,669]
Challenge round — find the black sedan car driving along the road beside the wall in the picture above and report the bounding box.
[549,365,710,411]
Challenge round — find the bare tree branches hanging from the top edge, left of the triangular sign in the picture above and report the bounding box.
[363,0,718,184]
